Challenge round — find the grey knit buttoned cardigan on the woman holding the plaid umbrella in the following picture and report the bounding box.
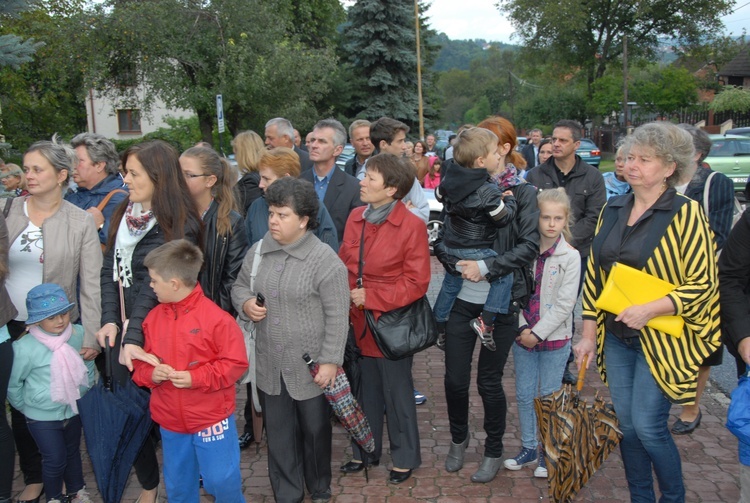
[232,231,349,400]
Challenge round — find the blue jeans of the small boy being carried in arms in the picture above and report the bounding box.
[432,248,513,322]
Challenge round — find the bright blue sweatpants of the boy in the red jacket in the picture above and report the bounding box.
[161,415,245,503]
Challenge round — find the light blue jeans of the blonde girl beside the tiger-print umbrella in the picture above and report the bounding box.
[513,341,570,449]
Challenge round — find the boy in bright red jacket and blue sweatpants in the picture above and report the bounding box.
[133,239,248,503]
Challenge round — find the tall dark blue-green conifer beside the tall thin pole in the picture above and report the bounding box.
[343,0,419,125]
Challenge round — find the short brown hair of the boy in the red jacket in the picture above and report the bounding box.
[143,239,203,288]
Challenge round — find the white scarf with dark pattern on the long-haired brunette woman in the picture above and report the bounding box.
[112,201,156,288]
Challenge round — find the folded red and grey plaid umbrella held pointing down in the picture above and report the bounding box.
[302,353,375,452]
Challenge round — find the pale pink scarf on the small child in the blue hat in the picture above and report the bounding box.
[29,323,88,414]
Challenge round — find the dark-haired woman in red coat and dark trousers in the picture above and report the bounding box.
[339,153,430,484]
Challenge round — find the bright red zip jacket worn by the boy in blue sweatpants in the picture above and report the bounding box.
[133,285,248,433]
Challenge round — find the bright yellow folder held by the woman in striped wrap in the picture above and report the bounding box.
[596,262,685,337]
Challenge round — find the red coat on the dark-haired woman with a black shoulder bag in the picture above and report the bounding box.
[339,201,431,358]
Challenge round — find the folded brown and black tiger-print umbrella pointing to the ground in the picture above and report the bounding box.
[534,361,622,503]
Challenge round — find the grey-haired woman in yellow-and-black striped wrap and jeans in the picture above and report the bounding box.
[574,122,720,502]
